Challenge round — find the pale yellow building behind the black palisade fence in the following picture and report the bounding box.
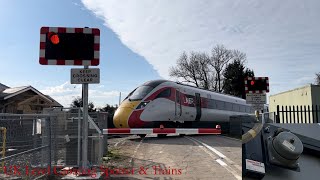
[269,84,320,123]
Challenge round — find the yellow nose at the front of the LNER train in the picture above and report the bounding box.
[113,107,133,128]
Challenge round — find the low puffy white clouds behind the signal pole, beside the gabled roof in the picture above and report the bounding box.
[40,82,119,107]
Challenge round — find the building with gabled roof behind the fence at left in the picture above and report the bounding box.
[0,83,63,114]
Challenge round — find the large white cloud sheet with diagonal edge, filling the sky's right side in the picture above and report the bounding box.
[82,0,320,95]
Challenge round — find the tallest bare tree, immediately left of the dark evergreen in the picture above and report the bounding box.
[210,45,233,92]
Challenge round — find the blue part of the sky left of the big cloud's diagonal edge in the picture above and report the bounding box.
[0,0,161,105]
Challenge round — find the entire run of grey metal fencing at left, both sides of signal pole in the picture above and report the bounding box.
[0,108,108,179]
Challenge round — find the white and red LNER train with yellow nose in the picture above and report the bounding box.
[113,80,267,133]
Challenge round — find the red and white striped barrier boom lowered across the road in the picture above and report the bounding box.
[103,128,221,134]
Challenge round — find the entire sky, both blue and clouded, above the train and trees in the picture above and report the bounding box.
[0,0,320,105]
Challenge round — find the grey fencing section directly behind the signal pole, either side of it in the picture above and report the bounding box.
[45,108,108,167]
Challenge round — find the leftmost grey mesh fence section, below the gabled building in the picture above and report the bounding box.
[0,114,51,179]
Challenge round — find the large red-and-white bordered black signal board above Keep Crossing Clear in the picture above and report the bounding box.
[39,27,100,66]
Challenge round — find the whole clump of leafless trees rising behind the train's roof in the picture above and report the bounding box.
[170,45,247,92]
